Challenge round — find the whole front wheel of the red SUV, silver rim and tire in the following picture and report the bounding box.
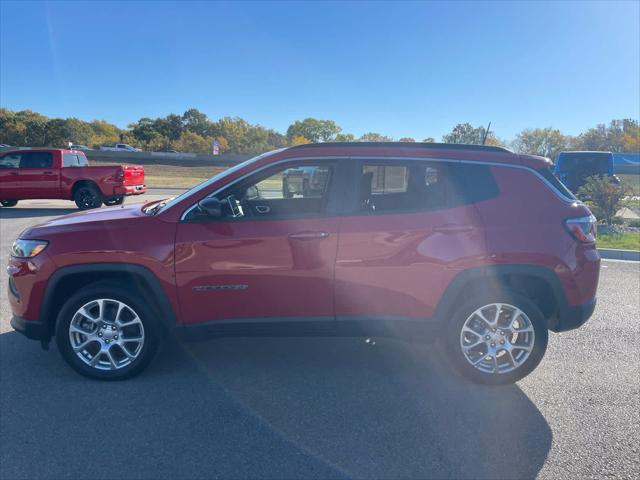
[56,283,161,380]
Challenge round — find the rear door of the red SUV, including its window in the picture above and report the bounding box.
[335,160,495,322]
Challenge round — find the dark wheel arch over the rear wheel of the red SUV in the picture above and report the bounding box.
[435,264,566,328]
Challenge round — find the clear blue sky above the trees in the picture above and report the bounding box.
[0,0,640,140]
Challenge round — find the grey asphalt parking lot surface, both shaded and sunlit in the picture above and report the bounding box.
[0,196,640,479]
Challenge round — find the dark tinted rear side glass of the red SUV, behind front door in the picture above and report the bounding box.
[359,161,498,213]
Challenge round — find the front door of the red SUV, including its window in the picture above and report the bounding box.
[175,161,340,323]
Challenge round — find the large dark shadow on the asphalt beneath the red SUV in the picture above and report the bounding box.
[0,332,552,479]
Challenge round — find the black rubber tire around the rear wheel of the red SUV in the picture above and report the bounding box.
[443,291,549,385]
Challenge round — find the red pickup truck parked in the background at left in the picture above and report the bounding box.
[0,148,147,210]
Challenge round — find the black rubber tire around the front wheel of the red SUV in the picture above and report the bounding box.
[55,282,163,380]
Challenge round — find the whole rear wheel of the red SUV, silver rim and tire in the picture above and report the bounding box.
[444,292,548,385]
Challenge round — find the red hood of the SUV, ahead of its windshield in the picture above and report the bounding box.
[20,203,147,239]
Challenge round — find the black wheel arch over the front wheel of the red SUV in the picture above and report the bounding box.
[40,263,176,337]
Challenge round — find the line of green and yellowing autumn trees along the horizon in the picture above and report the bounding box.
[0,108,640,159]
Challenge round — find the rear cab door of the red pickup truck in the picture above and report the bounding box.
[17,152,60,198]
